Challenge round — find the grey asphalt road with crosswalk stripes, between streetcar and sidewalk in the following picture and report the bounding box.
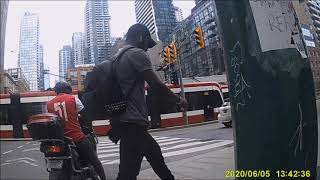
[0,123,233,179]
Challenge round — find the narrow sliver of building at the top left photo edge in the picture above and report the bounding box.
[0,0,9,73]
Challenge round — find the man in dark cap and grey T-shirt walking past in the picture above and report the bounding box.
[111,24,187,180]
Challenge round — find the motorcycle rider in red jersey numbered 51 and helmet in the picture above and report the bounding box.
[47,82,106,180]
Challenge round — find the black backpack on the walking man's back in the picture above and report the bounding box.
[81,46,136,121]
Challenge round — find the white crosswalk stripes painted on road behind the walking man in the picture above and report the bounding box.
[98,136,233,165]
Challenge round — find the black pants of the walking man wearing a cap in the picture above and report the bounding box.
[117,123,174,180]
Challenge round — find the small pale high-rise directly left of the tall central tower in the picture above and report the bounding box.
[72,32,84,65]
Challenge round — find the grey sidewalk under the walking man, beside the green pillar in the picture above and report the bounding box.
[138,146,234,180]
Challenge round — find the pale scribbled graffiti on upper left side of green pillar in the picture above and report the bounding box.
[230,41,251,111]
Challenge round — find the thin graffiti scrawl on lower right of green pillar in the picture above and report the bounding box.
[289,104,307,157]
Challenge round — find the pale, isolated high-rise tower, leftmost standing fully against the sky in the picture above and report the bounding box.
[18,12,41,91]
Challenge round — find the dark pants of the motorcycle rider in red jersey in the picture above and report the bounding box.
[75,137,106,180]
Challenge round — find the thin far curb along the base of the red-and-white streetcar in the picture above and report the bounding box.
[0,120,218,141]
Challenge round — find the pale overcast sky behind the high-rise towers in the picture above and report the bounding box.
[4,0,195,84]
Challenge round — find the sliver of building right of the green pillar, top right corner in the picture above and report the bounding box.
[292,0,320,97]
